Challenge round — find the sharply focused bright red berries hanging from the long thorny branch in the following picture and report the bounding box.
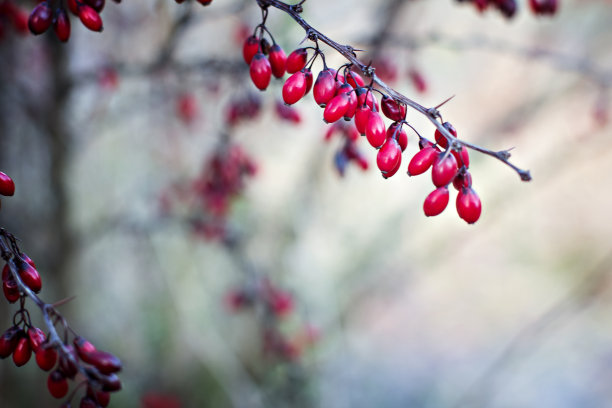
[243,25,481,224]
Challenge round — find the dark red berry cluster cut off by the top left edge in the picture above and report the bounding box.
[28,0,121,42]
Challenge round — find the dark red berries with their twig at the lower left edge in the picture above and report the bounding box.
[0,172,121,408]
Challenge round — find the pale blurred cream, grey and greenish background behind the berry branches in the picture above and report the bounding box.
[0,0,612,408]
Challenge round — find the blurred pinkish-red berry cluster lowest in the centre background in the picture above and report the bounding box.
[225,277,318,361]
